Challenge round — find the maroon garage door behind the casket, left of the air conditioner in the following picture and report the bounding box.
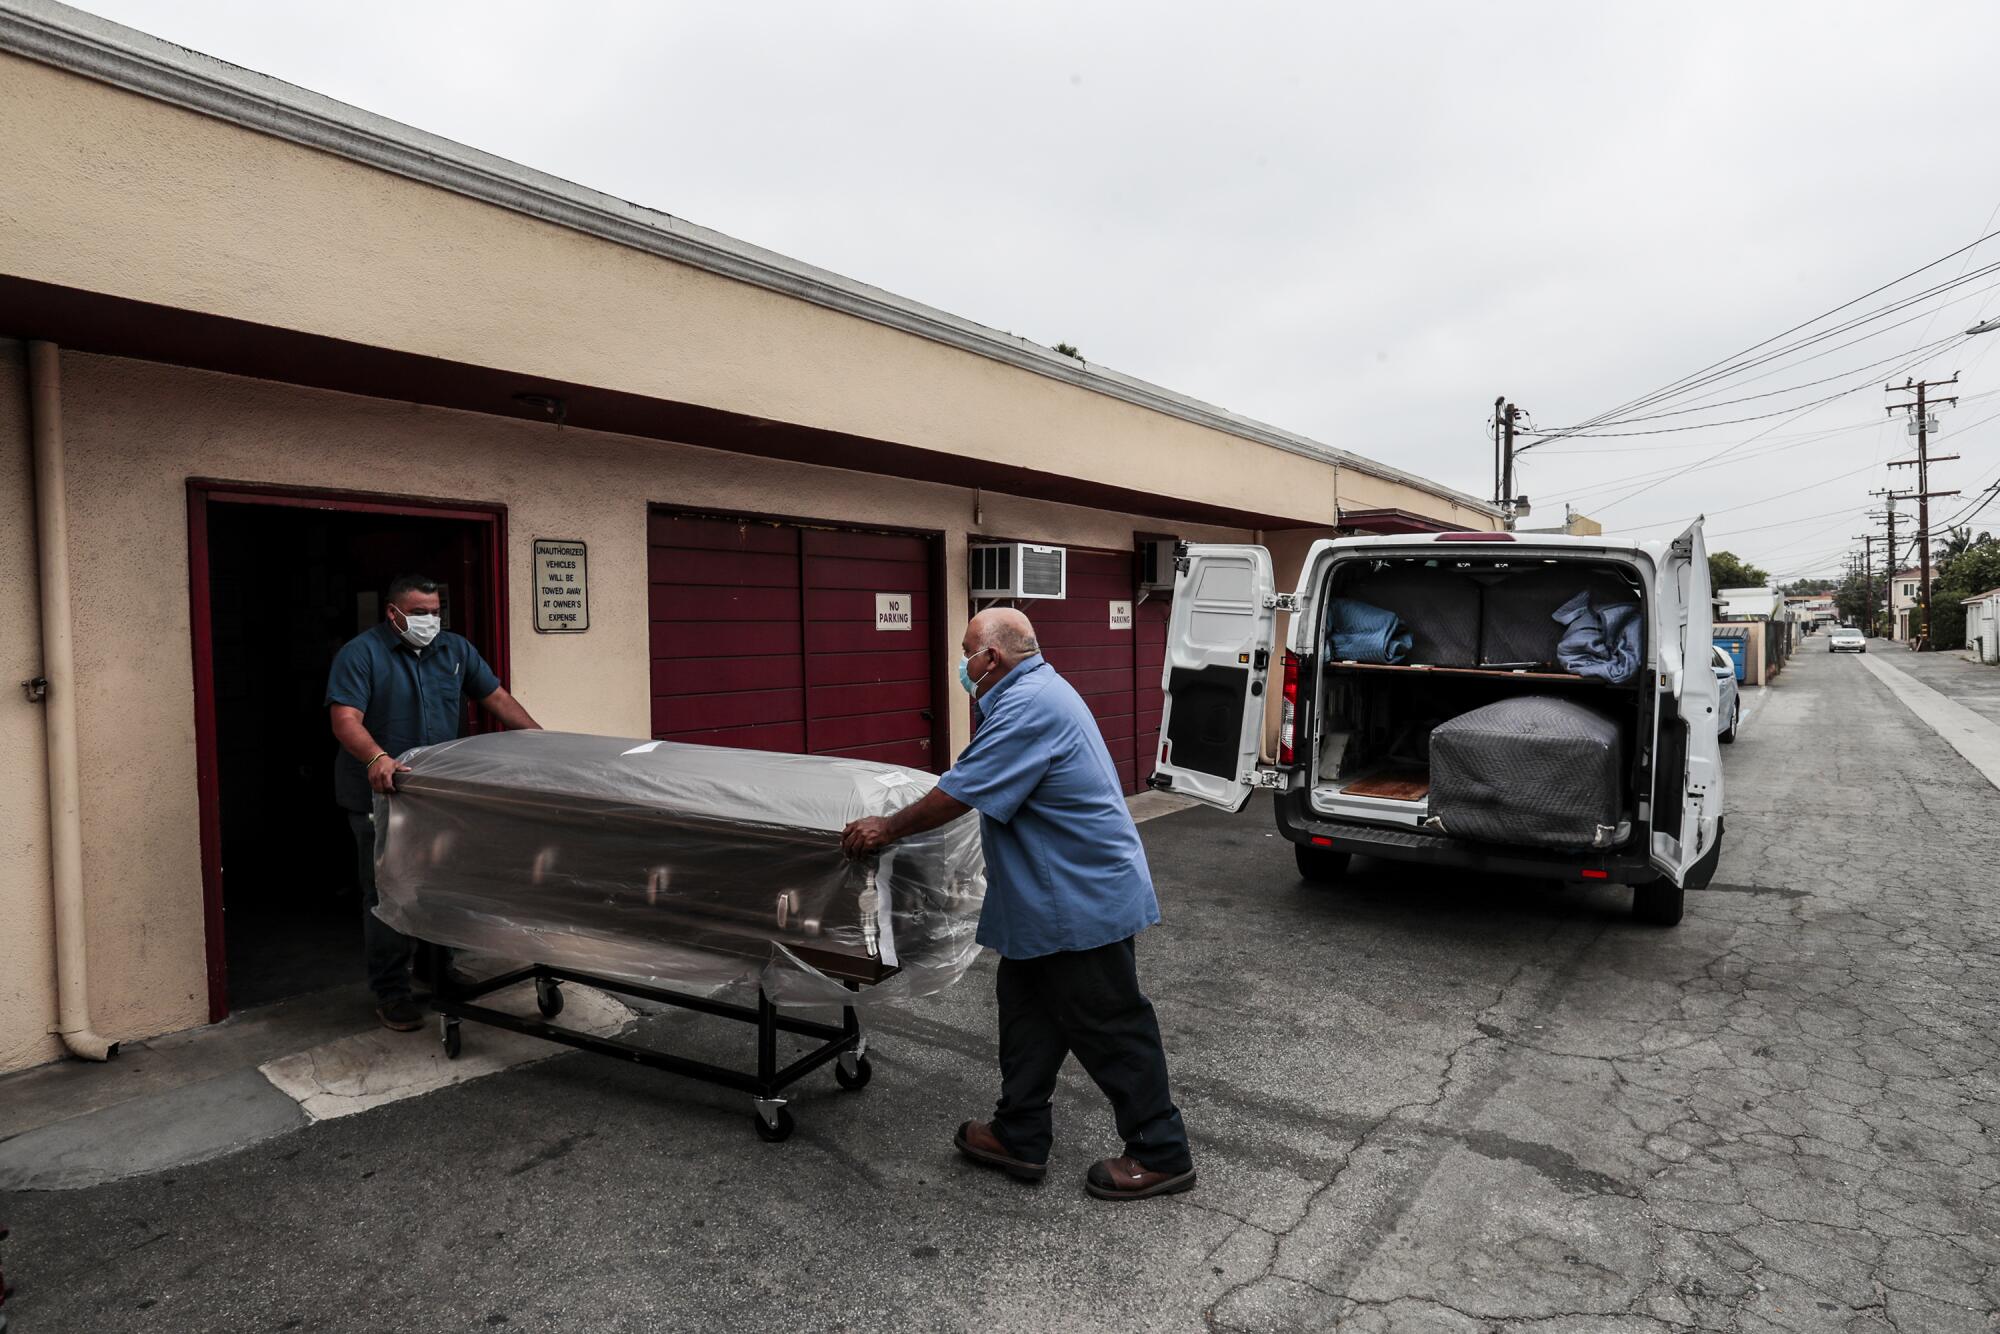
[648,512,938,768]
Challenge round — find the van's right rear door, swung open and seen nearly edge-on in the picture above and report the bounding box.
[1652,520,1722,890]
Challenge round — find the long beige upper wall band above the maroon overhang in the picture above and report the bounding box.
[0,54,1490,526]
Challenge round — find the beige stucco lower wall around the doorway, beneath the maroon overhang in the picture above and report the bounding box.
[0,354,1250,1066]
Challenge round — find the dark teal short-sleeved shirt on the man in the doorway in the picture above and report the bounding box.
[326,620,500,810]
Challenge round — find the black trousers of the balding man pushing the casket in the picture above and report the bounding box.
[992,938,1194,1172]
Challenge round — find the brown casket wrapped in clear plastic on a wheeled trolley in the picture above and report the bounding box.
[374,732,986,1004]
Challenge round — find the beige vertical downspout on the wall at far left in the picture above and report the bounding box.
[28,342,118,1060]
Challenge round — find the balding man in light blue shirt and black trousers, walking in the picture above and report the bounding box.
[842,608,1194,1200]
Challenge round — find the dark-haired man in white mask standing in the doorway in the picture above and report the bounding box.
[326,574,542,1032]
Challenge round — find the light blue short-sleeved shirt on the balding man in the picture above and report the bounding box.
[938,656,1160,958]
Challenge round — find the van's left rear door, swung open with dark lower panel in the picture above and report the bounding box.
[1152,546,1278,810]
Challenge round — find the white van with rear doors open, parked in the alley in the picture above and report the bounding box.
[1150,522,1722,926]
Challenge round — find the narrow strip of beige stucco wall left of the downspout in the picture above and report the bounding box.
[0,338,60,1070]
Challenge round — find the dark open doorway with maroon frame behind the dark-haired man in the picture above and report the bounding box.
[190,486,506,1018]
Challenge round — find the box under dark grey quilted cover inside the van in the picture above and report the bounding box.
[1430,694,1624,848]
